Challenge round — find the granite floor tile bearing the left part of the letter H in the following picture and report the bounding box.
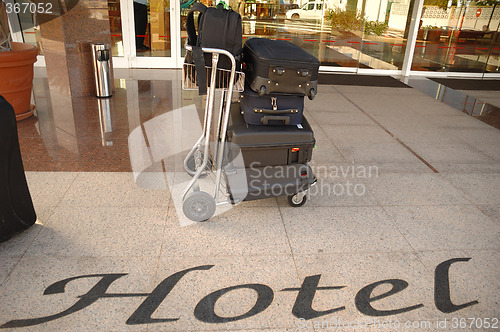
[0,257,158,331]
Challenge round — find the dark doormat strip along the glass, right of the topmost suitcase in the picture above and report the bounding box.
[318,74,411,88]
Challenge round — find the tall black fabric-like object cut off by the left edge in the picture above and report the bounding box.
[0,96,36,242]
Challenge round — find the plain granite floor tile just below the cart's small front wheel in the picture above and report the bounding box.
[281,206,412,255]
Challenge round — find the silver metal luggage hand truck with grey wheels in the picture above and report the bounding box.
[182,45,316,222]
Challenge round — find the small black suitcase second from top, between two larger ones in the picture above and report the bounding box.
[240,86,304,125]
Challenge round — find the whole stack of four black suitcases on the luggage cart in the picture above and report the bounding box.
[227,38,320,206]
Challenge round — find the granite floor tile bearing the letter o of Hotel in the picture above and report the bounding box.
[152,253,300,331]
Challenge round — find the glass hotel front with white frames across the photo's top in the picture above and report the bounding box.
[7,0,500,77]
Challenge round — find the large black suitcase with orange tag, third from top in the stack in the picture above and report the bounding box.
[227,103,316,167]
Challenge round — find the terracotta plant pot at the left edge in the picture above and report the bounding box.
[0,42,38,121]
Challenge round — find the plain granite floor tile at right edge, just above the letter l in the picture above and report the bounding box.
[385,206,500,251]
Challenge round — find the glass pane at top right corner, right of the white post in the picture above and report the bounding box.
[412,0,500,73]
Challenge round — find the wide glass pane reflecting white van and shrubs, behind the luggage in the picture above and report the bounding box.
[200,0,409,69]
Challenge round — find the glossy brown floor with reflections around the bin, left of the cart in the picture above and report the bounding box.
[18,70,202,172]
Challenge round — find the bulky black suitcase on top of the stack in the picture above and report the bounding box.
[242,38,320,99]
